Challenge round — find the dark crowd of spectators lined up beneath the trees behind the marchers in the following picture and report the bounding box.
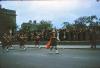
[17,29,94,41]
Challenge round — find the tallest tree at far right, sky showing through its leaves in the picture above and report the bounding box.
[75,15,100,28]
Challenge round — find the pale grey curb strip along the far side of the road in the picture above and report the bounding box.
[0,45,100,49]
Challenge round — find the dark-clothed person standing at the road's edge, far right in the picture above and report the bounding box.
[89,28,96,48]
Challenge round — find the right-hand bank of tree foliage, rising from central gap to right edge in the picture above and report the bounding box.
[63,15,100,29]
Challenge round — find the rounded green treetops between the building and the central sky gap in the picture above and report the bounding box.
[21,20,52,32]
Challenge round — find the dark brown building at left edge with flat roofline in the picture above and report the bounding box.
[0,6,16,34]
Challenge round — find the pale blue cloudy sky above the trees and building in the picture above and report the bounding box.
[0,0,100,28]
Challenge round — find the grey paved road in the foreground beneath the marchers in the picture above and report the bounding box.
[0,47,100,68]
